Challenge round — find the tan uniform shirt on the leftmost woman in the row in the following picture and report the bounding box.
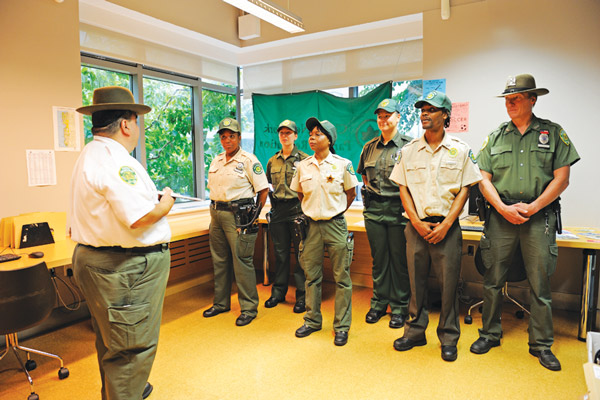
[208,149,269,202]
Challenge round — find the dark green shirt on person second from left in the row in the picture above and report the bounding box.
[267,145,308,200]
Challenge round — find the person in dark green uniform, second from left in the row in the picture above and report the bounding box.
[265,119,308,313]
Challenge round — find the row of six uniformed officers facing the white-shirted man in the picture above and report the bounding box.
[204,74,579,370]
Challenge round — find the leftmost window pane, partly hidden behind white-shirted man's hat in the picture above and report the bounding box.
[81,64,131,144]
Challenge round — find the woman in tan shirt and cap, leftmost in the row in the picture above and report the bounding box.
[203,118,269,326]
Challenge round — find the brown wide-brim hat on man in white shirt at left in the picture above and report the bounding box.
[77,86,152,115]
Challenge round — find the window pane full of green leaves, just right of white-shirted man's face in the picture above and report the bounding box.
[143,78,195,196]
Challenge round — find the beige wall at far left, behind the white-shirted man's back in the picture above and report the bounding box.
[0,0,83,218]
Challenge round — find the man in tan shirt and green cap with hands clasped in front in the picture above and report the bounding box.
[390,91,481,361]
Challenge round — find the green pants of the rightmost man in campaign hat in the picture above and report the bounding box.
[479,210,558,350]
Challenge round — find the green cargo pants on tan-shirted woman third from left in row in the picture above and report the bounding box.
[300,218,354,332]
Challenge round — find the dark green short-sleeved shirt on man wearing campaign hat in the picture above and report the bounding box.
[477,115,579,202]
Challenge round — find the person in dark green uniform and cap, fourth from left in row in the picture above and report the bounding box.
[356,99,412,328]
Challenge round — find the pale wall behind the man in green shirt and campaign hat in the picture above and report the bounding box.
[423,0,600,309]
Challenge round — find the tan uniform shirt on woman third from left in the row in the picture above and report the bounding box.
[290,153,358,220]
